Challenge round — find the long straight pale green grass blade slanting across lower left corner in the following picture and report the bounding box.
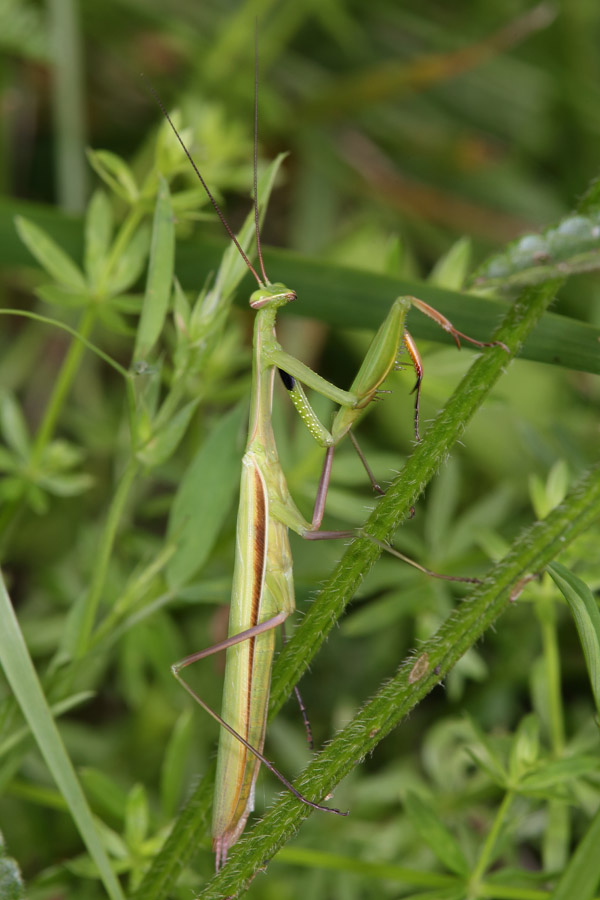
[0,576,123,900]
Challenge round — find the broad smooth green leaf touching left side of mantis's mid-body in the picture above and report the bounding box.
[167,403,246,588]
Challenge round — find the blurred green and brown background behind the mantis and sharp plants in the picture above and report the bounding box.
[0,0,600,900]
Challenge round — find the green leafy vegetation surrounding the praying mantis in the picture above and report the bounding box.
[0,0,600,900]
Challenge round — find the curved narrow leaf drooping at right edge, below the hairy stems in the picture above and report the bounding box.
[548,562,600,715]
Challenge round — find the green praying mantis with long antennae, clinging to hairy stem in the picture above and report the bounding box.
[157,67,504,869]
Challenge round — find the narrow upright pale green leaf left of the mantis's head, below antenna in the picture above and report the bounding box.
[133,178,175,360]
